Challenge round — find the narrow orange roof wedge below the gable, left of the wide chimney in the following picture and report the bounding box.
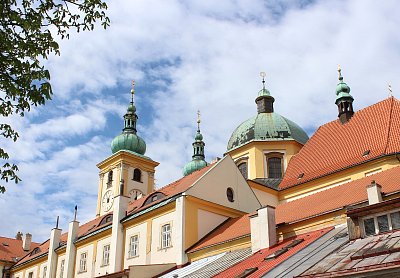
[187,214,252,253]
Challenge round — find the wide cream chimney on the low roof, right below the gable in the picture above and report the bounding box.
[250,206,276,253]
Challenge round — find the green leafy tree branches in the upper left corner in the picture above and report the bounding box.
[0,0,110,193]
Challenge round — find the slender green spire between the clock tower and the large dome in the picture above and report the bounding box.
[183,111,208,176]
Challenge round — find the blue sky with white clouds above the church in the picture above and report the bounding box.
[0,0,400,242]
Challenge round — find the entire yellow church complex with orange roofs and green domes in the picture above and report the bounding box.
[0,69,400,278]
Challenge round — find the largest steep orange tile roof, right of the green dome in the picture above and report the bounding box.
[279,97,400,189]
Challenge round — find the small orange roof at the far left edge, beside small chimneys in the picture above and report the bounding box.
[0,236,39,263]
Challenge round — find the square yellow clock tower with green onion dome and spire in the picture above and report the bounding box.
[96,82,159,216]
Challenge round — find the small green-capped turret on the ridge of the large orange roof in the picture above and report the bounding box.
[335,65,354,124]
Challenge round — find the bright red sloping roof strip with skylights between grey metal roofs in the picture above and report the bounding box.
[214,228,332,278]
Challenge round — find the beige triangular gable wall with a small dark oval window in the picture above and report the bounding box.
[185,156,261,213]
